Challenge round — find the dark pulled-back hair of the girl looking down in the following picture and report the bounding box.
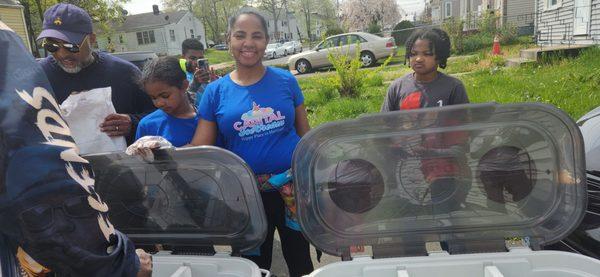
[138,57,186,88]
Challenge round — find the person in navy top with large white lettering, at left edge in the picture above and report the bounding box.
[0,18,152,277]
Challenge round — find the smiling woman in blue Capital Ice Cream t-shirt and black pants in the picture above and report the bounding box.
[191,12,313,276]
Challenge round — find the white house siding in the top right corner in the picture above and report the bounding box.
[535,0,600,45]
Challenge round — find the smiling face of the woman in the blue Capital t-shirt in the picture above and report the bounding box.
[229,14,269,67]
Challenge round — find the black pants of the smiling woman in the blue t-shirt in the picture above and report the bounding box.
[244,191,314,277]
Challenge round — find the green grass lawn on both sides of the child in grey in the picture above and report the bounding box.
[299,46,600,127]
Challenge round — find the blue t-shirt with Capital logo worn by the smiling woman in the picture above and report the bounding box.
[198,67,304,174]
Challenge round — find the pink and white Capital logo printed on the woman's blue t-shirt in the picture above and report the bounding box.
[233,102,285,139]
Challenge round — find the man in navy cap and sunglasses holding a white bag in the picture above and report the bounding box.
[37,3,154,143]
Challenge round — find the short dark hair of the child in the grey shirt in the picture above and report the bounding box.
[405,28,450,68]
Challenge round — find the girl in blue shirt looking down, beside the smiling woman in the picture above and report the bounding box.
[135,57,198,147]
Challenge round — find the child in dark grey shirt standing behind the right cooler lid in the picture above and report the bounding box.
[381,28,470,214]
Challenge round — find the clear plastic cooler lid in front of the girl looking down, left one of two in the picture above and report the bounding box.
[85,146,267,251]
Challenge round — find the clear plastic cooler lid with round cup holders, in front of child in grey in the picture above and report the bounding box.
[293,103,586,256]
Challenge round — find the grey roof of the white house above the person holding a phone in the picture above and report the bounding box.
[111,10,188,32]
